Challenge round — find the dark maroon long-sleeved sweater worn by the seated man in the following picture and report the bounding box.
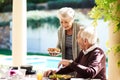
[57,48,106,80]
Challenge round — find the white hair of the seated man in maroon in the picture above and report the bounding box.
[80,27,98,44]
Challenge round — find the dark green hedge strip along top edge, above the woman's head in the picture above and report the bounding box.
[47,0,95,9]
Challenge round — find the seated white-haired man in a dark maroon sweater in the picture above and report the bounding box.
[44,27,106,80]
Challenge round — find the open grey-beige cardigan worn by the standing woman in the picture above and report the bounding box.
[57,23,81,60]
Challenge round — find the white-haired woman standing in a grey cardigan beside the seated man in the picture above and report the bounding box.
[49,7,82,60]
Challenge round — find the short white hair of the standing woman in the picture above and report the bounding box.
[58,7,75,19]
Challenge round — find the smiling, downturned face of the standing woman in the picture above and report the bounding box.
[60,18,73,30]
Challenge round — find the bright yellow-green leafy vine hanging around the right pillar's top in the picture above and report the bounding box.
[89,0,120,32]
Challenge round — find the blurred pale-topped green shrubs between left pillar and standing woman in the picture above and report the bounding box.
[27,11,60,29]
